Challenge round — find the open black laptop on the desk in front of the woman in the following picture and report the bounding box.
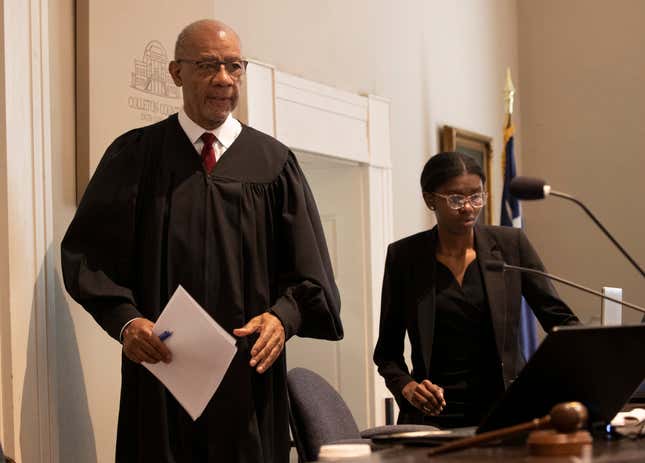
[370,324,645,444]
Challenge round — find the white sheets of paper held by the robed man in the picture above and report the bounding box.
[142,286,237,420]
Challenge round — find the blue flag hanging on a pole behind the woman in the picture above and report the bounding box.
[500,112,538,360]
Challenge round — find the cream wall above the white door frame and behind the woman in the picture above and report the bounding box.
[215,0,519,238]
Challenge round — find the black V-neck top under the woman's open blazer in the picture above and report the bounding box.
[429,259,504,427]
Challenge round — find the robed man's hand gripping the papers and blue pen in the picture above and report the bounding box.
[123,318,172,363]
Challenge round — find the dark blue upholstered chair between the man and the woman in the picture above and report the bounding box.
[287,368,437,462]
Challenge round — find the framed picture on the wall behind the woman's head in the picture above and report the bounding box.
[440,125,494,224]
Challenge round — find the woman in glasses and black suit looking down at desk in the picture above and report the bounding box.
[374,152,578,427]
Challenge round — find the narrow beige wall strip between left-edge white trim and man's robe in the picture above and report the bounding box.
[49,0,109,462]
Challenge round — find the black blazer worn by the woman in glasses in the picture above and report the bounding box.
[374,225,578,421]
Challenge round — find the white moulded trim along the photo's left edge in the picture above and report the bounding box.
[0,0,57,461]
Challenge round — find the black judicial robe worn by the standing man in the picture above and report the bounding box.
[62,115,343,463]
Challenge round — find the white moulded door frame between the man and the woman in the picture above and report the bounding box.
[236,61,393,426]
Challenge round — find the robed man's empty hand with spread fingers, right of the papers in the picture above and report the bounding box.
[233,312,284,373]
